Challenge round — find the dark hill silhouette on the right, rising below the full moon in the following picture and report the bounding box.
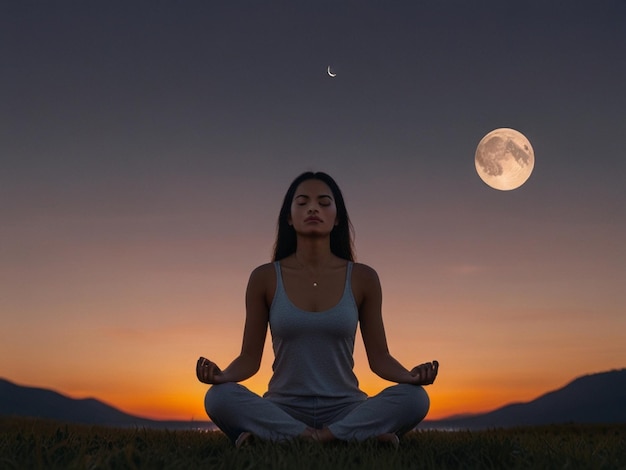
[419,369,626,429]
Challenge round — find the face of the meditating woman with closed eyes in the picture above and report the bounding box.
[289,179,338,235]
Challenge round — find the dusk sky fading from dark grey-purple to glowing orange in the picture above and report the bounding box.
[0,0,626,420]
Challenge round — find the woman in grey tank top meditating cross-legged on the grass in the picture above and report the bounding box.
[196,172,439,445]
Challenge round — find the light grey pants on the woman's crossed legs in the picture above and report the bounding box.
[204,383,430,441]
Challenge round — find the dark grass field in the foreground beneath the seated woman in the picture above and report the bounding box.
[0,418,626,470]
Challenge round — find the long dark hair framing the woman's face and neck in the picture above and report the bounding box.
[272,171,354,261]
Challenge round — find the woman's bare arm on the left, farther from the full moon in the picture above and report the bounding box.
[196,265,274,384]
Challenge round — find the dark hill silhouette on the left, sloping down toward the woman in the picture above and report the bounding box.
[0,379,215,429]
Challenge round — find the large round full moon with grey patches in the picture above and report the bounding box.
[474,127,535,191]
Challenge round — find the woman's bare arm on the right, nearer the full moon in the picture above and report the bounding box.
[354,264,439,385]
